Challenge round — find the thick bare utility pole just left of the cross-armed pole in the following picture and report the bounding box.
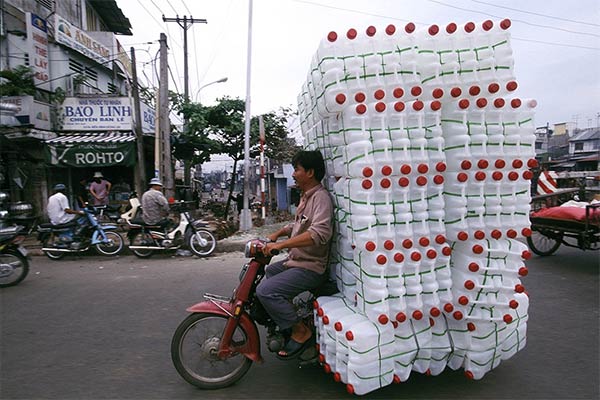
[157,33,175,198]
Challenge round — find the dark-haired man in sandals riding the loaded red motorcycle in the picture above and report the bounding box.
[256,151,333,357]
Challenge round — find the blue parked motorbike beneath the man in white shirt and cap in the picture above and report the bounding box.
[37,205,123,260]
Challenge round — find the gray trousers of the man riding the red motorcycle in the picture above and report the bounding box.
[256,260,326,329]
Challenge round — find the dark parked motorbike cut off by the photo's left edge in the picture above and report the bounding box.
[0,225,30,288]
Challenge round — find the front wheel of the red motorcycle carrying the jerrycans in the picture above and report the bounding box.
[171,313,252,389]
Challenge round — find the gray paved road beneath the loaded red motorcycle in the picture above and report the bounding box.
[0,249,600,399]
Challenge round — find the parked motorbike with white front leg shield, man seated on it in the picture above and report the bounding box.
[122,199,217,258]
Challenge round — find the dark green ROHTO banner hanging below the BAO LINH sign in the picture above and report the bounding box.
[44,142,135,167]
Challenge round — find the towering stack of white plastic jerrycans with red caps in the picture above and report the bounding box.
[298,20,536,394]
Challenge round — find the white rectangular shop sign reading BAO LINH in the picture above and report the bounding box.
[60,97,133,132]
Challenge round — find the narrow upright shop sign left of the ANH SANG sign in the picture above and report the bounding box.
[26,12,50,90]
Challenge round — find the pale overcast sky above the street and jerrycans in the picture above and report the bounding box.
[117,0,600,170]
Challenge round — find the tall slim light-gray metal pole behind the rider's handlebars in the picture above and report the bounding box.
[240,0,252,231]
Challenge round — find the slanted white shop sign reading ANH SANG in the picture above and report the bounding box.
[54,15,111,67]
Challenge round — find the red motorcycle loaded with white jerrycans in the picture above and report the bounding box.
[171,239,337,389]
